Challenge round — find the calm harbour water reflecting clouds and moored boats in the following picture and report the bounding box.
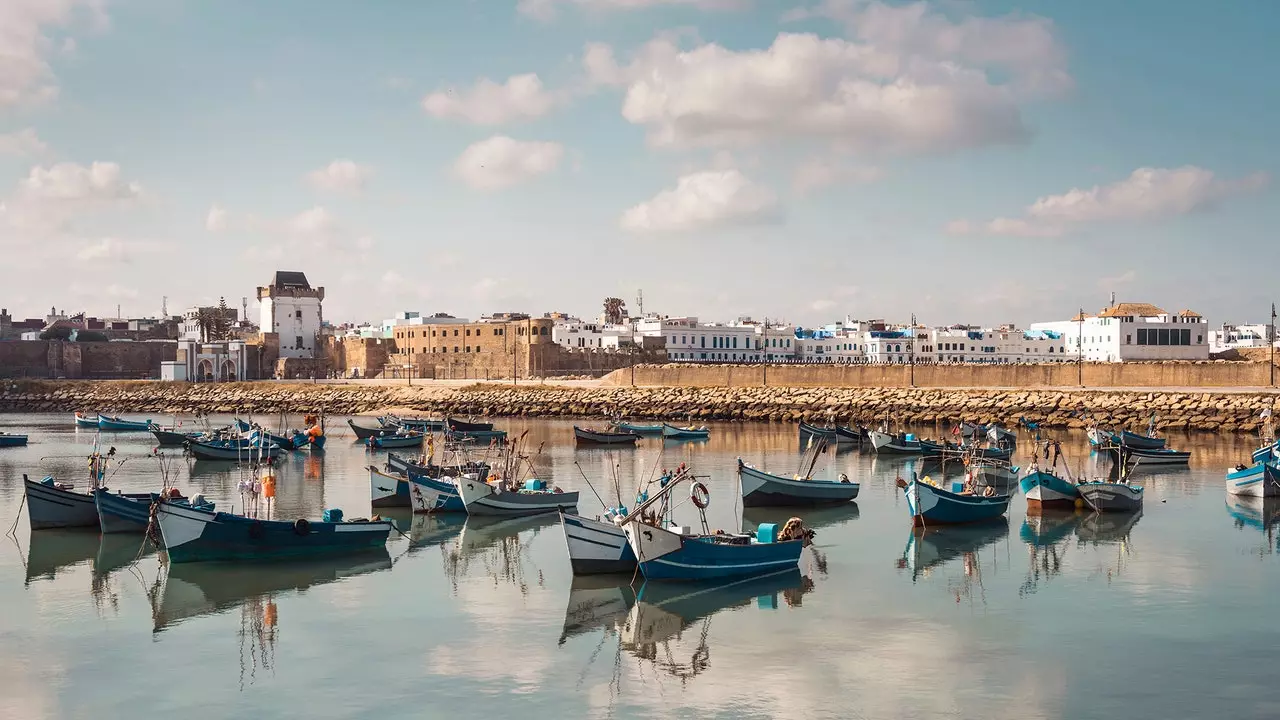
[0,415,1280,720]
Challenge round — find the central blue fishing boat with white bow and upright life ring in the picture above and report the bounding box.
[622,466,813,580]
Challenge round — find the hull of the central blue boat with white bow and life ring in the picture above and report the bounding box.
[623,523,804,580]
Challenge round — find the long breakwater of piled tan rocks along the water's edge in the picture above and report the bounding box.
[0,380,1280,432]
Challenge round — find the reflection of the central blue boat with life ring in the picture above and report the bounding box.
[618,569,814,684]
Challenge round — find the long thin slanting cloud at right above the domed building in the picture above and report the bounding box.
[947,165,1270,237]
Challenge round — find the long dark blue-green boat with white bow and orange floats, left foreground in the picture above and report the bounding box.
[156,502,392,562]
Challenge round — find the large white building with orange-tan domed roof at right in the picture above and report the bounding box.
[1032,302,1208,363]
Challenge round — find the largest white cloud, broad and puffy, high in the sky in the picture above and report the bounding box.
[584,33,1029,152]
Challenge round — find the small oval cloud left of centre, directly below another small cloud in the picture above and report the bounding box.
[422,73,556,126]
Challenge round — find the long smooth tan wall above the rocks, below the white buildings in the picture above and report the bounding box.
[604,361,1271,388]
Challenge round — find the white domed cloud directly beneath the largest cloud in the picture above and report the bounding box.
[621,170,780,232]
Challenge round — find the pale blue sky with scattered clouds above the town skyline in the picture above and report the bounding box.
[0,0,1280,325]
